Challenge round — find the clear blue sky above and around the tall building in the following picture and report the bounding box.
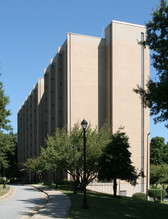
[0,0,168,141]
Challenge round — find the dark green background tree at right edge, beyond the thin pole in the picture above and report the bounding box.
[150,137,168,165]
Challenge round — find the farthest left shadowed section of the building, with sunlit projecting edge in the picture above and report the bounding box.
[18,78,44,165]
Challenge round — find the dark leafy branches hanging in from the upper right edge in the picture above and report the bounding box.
[134,0,168,127]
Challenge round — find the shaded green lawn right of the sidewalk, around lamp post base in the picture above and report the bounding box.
[63,190,168,219]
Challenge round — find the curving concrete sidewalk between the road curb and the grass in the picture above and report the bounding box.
[32,185,71,219]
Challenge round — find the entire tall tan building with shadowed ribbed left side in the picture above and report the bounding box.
[18,21,149,194]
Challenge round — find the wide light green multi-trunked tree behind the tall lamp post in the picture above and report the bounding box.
[41,124,110,191]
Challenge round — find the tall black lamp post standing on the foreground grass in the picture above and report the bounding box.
[81,119,88,209]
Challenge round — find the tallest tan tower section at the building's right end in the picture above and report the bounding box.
[106,21,149,192]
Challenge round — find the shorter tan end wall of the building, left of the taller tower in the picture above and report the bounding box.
[67,33,106,129]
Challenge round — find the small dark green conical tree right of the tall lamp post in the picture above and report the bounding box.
[98,129,142,196]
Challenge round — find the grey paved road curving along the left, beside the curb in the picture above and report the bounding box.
[0,185,41,219]
